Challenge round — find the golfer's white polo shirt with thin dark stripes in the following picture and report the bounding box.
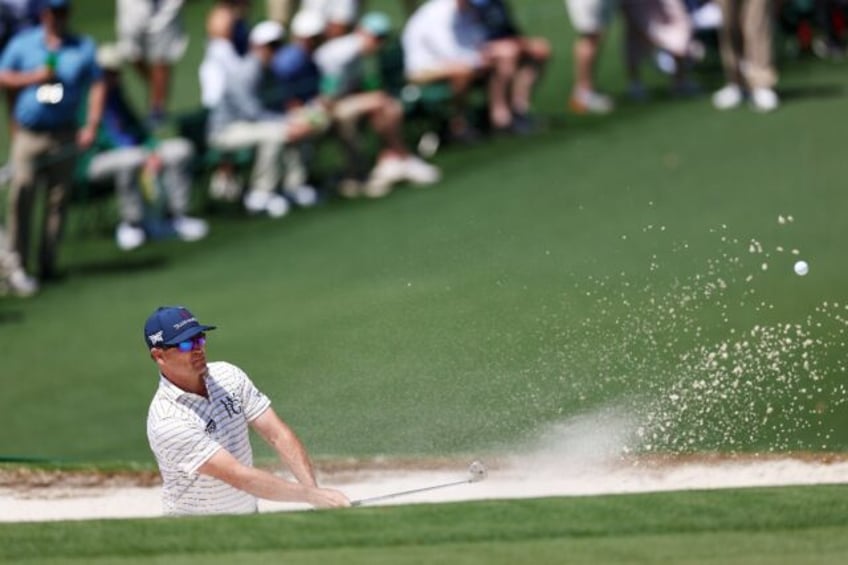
[147,362,271,515]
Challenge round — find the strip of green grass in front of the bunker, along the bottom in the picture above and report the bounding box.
[0,486,848,564]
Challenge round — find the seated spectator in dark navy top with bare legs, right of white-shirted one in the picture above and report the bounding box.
[471,0,551,133]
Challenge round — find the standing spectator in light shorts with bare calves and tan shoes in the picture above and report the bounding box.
[565,0,615,114]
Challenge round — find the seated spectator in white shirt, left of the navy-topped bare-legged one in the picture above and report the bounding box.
[402,0,490,141]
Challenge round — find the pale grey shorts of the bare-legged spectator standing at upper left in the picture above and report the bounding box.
[117,0,188,63]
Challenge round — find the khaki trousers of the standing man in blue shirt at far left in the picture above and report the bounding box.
[6,128,77,277]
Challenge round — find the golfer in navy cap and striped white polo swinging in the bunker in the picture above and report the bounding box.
[144,306,350,515]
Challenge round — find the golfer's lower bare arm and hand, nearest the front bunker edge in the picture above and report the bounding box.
[198,449,350,508]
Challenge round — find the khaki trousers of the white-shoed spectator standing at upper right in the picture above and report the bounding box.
[719,0,777,88]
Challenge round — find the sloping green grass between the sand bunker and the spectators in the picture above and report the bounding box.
[0,3,848,465]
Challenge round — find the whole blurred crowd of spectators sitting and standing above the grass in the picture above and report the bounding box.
[0,0,848,296]
